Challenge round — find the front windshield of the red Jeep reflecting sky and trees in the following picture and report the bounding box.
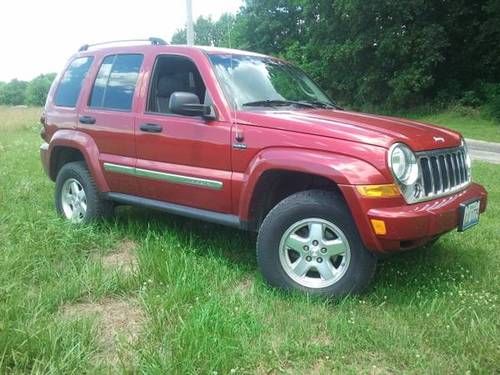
[210,54,334,108]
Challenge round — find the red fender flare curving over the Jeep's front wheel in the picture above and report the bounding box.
[238,147,390,221]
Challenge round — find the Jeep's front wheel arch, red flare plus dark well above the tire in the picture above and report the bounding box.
[239,148,387,230]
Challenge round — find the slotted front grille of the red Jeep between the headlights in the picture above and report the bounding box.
[418,147,470,198]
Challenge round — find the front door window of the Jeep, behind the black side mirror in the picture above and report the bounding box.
[147,55,211,113]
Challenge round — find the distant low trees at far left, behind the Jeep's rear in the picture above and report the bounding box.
[0,73,56,106]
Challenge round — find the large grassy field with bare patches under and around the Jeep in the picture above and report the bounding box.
[0,109,500,374]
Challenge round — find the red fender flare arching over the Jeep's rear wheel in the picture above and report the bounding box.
[48,129,109,193]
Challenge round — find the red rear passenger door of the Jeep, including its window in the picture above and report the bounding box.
[78,53,144,195]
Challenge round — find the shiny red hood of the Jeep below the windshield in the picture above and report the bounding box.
[237,109,461,151]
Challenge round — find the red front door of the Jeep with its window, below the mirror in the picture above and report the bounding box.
[135,55,231,213]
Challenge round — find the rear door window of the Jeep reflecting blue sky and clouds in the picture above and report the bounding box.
[89,54,143,111]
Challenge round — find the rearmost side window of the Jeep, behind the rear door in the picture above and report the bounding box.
[54,57,93,107]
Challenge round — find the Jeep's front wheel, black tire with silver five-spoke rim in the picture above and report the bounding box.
[257,190,377,297]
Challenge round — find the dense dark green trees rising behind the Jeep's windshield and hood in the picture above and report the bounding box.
[172,0,500,118]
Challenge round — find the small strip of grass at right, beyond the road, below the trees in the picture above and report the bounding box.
[411,108,500,143]
